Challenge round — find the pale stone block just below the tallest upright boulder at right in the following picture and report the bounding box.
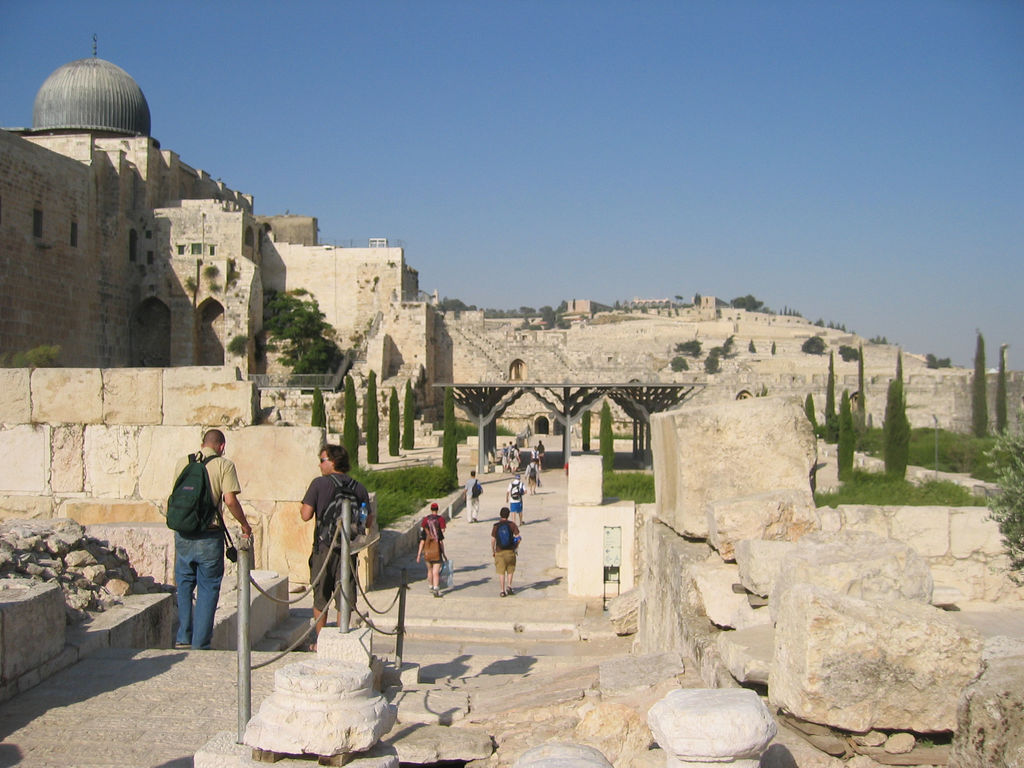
[708,487,821,560]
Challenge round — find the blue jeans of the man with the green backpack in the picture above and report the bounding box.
[174,530,224,650]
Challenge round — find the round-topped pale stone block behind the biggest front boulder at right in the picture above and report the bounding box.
[769,531,933,618]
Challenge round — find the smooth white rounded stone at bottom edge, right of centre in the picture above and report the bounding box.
[647,688,777,768]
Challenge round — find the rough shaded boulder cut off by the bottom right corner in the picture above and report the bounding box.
[949,649,1024,768]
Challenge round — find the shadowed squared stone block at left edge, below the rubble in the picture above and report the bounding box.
[0,579,66,682]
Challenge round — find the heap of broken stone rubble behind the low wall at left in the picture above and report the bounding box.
[0,518,163,624]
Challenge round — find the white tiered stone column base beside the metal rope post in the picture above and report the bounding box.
[244,658,396,757]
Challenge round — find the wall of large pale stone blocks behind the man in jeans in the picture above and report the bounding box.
[0,368,324,581]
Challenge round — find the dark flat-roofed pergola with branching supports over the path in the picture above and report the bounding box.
[434,381,703,474]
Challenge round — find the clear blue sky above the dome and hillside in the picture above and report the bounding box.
[0,0,1024,370]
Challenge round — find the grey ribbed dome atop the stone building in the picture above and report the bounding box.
[32,57,150,136]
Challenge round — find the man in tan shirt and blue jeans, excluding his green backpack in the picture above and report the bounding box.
[174,429,253,650]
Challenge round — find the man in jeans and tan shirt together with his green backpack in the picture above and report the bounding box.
[167,429,252,650]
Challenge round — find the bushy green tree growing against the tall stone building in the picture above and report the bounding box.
[263,289,341,374]
